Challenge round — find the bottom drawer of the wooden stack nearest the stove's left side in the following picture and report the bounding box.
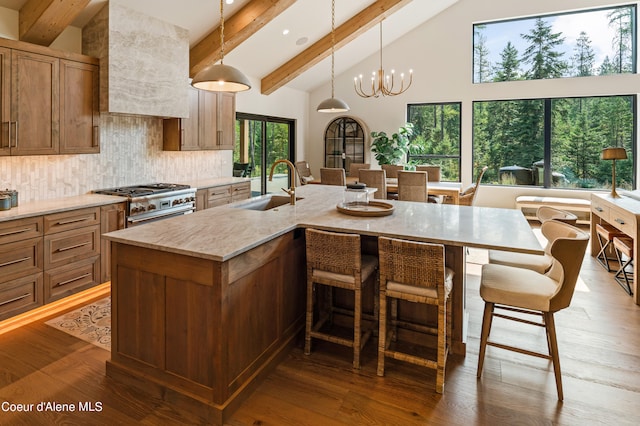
[44,256,100,303]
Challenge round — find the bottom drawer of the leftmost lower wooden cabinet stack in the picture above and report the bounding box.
[0,272,43,321]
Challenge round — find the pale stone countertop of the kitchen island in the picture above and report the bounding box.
[105,185,542,261]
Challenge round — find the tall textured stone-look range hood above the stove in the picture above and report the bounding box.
[82,1,189,117]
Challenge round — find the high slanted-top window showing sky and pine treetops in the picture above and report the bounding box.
[473,5,636,83]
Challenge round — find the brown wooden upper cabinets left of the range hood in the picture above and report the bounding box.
[0,40,100,155]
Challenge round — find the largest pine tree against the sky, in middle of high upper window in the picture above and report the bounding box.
[521,18,567,80]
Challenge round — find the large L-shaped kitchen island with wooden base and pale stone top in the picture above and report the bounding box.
[106,185,542,424]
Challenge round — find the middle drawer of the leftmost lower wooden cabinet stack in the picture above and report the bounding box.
[0,237,42,283]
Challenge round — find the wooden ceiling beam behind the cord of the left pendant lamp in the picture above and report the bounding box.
[189,0,296,77]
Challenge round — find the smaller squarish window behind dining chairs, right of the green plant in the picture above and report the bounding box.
[407,103,461,182]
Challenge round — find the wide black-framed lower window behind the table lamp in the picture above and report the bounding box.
[473,95,636,189]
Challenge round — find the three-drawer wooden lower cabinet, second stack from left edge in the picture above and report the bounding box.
[44,207,100,303]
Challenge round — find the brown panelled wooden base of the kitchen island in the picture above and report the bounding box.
[106,231,306,424]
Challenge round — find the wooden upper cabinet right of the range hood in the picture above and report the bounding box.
[162,88,236,151]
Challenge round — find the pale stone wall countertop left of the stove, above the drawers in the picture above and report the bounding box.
[0,194,126,222]
